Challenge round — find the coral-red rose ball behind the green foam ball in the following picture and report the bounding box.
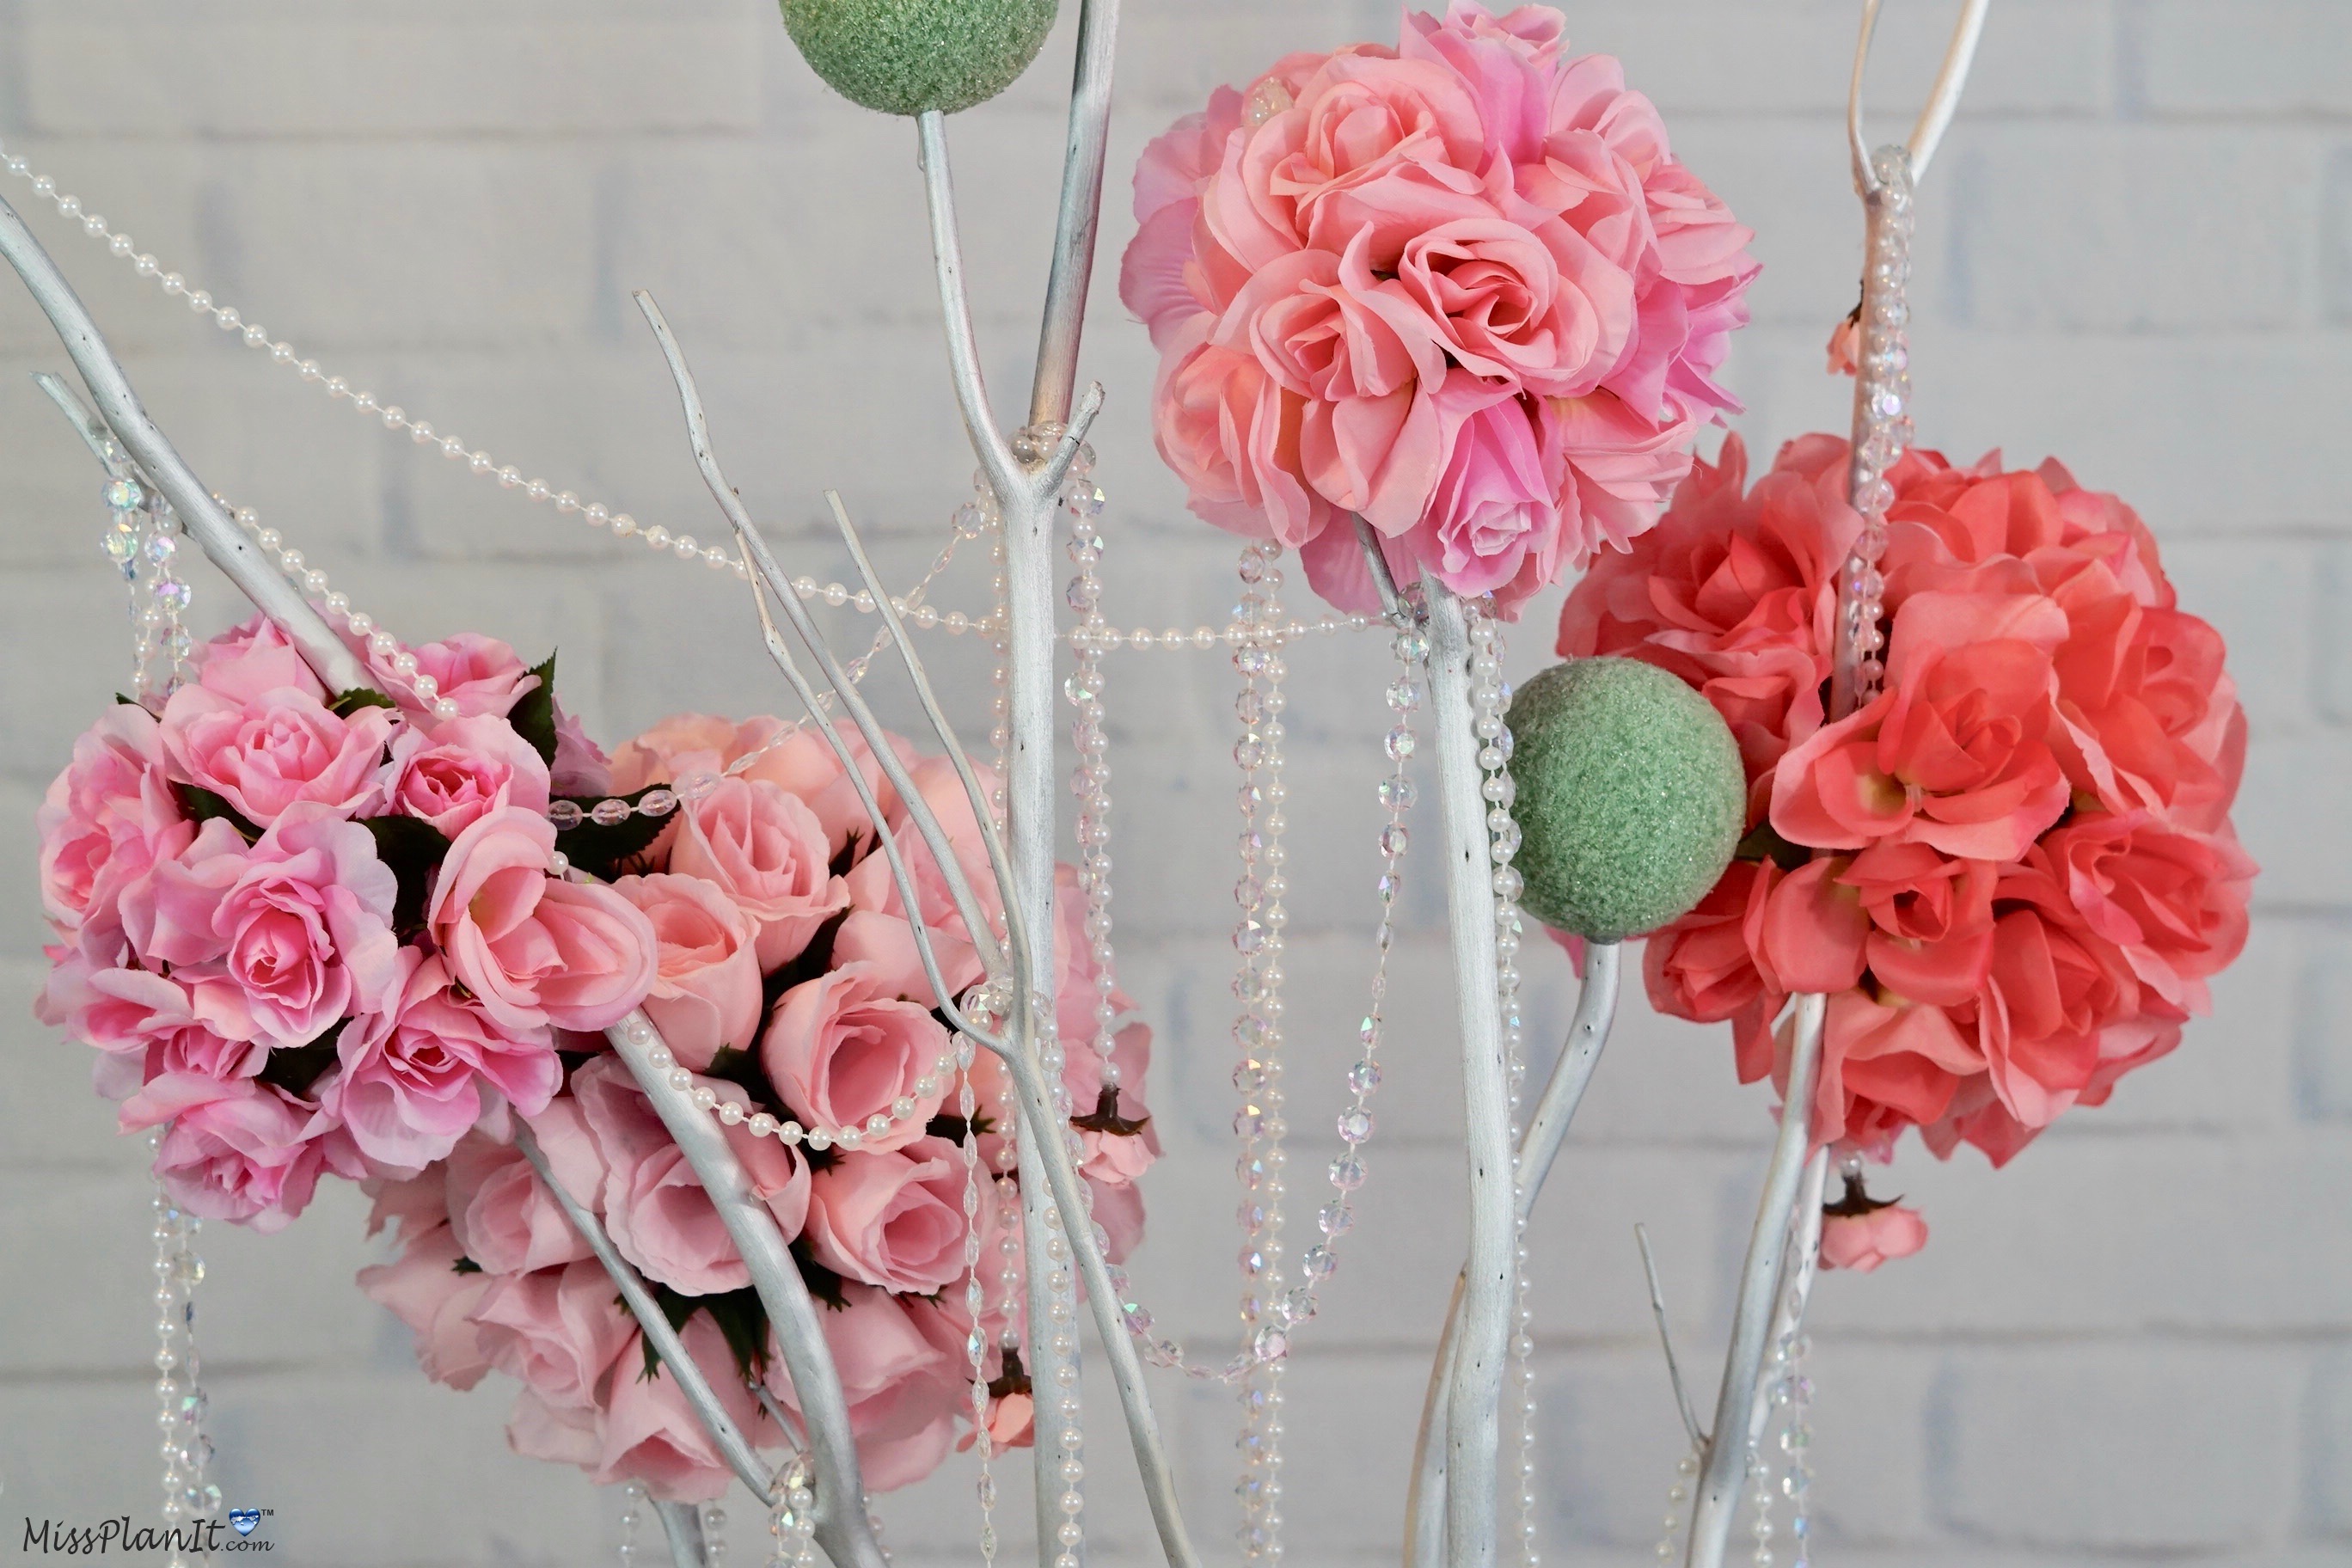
[1559,435,2253,1185]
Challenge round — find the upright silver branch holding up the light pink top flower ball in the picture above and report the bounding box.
[1423,576,1517,1568]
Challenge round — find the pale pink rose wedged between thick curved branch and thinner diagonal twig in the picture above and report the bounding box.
[572,1056,750,1295]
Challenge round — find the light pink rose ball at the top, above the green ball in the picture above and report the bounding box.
[1119,0,1757,614]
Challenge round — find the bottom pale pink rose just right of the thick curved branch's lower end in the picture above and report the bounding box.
[767,1283,969,1491]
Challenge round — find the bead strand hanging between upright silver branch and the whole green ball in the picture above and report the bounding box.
[1467,604,1538,1568]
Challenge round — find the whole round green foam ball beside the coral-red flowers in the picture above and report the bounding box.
[1508,658,1748,943]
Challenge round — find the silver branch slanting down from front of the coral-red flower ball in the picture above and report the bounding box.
[1684,995,1828,1568]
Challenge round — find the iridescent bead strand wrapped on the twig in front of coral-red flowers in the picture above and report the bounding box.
[1830,146,1912,717]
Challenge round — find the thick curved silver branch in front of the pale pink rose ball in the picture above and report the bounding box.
[604,1014,885,1568]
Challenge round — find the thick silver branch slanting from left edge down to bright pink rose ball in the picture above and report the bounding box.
[0,199,378,691]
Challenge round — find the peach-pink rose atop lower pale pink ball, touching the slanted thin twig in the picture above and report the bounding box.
[671,778,849,973]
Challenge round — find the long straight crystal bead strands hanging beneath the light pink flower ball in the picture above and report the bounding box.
[1233,543,1289,1564]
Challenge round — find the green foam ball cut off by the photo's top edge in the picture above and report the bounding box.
[783,0,1058,115]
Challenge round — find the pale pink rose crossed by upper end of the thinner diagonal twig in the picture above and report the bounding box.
[447,1095,604,1274]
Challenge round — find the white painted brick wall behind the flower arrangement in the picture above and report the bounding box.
[0,0,2352,1568]
